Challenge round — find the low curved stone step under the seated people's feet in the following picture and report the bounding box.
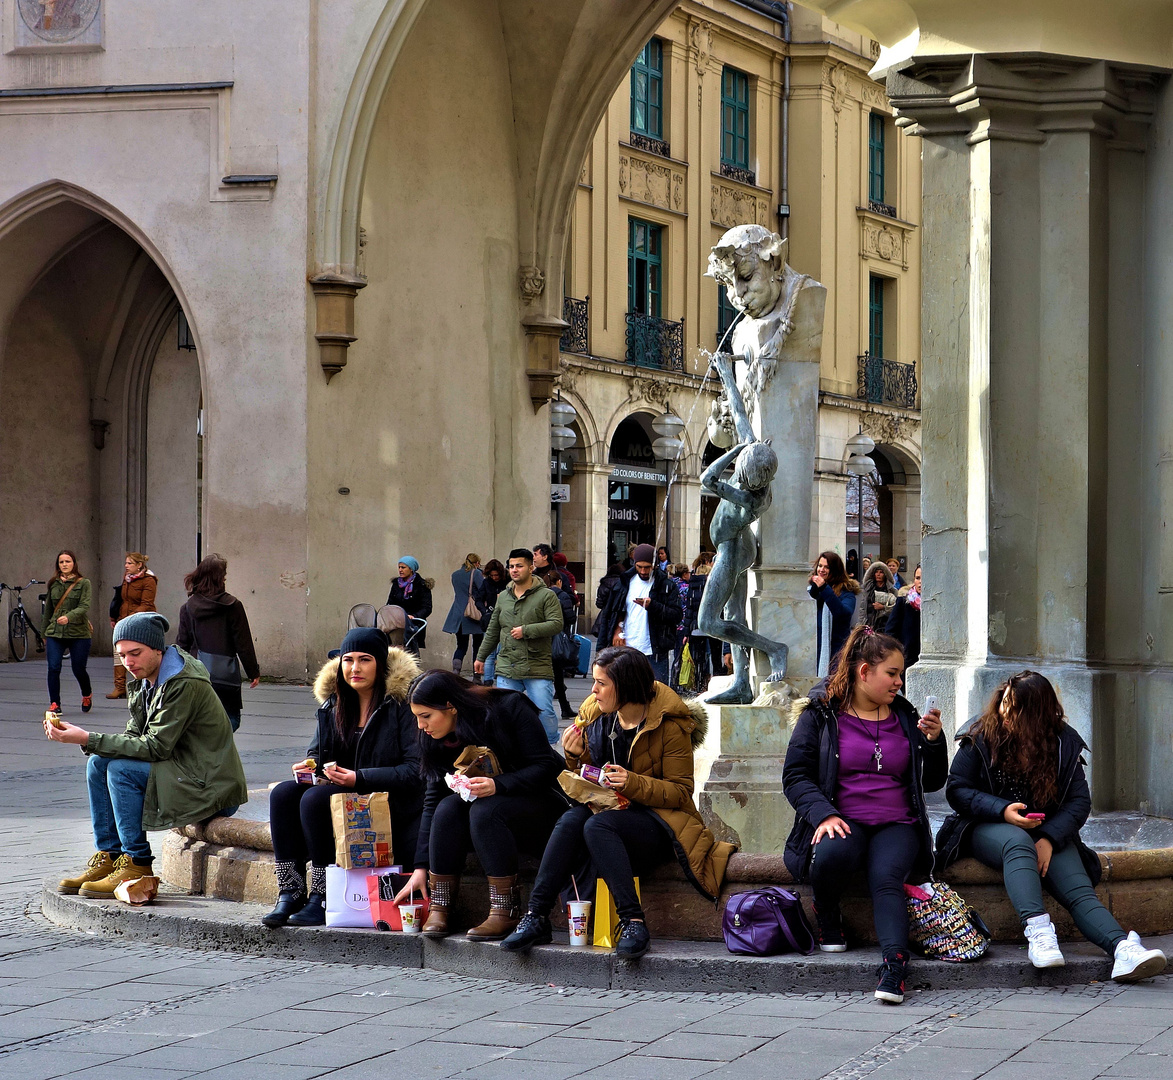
[41,879,1149,993]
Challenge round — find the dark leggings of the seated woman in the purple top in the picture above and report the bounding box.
[811,817,921,950]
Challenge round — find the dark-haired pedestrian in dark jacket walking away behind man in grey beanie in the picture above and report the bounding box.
[175,552,260,732]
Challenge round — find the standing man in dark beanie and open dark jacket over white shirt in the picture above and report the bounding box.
[598,544,684,685]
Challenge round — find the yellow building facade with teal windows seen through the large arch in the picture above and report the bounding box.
[552,0,921,606]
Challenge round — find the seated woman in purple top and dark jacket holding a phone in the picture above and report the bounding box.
[782,625,949,1004]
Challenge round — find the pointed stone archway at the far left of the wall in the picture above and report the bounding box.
[0,179,205,646]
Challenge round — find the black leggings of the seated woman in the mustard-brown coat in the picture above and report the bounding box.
[529,806,674,919]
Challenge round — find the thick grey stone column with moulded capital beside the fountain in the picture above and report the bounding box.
[888,54,1155,783]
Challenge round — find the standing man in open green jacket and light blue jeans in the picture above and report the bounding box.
[473,548,562,742]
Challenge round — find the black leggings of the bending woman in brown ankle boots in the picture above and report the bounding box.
[428,794,565,877]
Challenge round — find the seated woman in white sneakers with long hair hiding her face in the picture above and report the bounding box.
[937,671,1165,983]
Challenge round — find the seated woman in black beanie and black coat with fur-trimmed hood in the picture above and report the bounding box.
[262,626,423,926]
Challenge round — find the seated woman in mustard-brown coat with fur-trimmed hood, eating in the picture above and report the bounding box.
[501,646,734,959]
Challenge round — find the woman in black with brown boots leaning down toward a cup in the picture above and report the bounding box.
[395,671,568,942]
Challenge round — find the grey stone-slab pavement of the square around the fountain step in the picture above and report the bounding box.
[0,659,1173,1080]
